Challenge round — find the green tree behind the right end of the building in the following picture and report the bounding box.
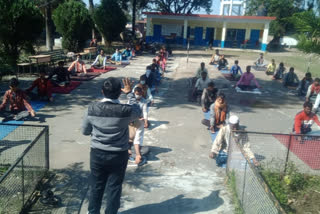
[247,0,304,44]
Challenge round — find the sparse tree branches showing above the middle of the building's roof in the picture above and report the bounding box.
[149,0,212,14]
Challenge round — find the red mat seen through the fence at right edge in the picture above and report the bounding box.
[273,135,320,169]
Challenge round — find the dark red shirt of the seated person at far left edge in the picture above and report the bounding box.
[0,89,33,112]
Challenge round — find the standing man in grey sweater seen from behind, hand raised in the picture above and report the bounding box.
[82,77,141,214]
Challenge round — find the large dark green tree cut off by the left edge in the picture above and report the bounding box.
[0,0,44,67]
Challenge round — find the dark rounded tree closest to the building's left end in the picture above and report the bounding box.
[93,0,127,46]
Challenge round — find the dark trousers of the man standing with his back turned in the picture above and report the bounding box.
[88,149,128,214]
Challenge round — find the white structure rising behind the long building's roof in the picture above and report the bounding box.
[220,0,246,16]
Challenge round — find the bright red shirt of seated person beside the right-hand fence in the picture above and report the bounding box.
[294,111,320,134]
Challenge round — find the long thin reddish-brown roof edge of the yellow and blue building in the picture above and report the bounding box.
[143,12,276,21]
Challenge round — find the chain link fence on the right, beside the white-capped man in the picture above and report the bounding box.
[227,132,320,214]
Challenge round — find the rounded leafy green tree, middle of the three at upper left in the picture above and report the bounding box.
[52,0,92,52]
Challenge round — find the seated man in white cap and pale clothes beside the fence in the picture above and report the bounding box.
[209,115,260,166]
